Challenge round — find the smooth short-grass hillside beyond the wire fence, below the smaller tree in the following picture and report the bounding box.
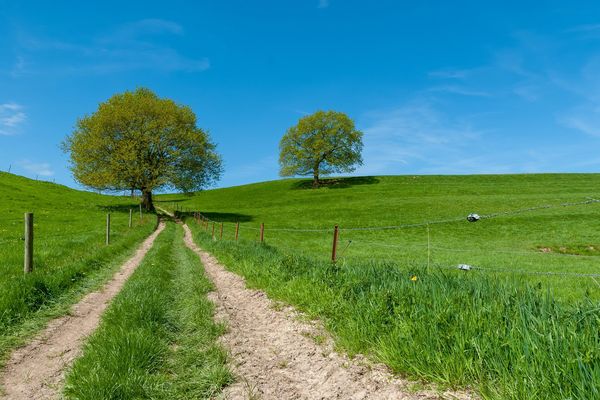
[159,174,600,299]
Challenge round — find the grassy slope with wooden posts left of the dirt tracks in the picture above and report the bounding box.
[0,172,156,358]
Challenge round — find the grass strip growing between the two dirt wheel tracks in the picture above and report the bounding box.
[65,223,231,399]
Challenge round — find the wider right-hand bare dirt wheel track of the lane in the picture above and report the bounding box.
[184,225,474,400]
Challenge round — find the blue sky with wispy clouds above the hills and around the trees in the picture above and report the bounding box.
[0,0,600,186]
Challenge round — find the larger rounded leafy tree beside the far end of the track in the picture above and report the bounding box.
[63,88,222,210]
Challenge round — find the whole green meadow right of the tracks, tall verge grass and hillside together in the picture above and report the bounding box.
[160,174,600,400]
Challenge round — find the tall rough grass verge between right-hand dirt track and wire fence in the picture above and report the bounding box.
[190,223,600,400]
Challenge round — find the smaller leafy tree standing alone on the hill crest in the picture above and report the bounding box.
[279,111,363,187]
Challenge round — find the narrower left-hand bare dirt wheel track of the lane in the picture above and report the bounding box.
[1,222,165,400]
